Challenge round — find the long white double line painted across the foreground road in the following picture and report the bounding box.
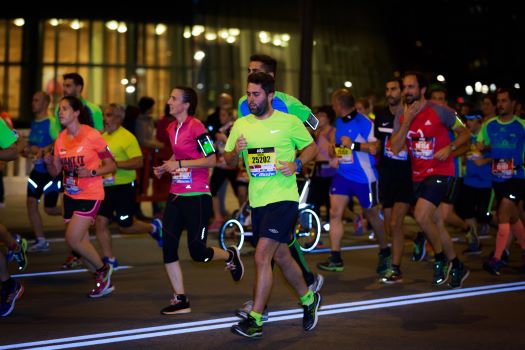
[0,282,525,349]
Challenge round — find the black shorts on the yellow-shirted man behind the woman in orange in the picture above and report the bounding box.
[98,183,135,227]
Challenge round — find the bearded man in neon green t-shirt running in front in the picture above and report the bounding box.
[224,72,321,338]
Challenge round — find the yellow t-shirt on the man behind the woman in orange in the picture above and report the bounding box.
[102,126,142,186]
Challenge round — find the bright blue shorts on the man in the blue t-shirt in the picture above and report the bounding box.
[330,174,379,209]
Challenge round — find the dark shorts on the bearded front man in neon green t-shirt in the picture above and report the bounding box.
[252,201,298,244]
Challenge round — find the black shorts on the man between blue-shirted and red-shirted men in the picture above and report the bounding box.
[379,169,414,208]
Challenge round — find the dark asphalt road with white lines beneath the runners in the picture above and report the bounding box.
[0,194,525,350]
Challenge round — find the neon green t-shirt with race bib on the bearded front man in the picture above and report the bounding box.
[225,110,313,207]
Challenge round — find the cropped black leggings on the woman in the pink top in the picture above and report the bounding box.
[162,193,213,264]
